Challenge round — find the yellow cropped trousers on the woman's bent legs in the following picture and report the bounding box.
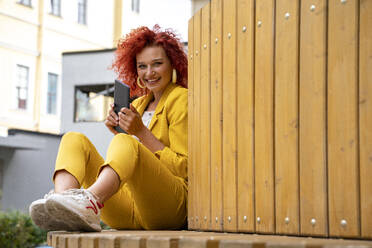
[55,132,187,229]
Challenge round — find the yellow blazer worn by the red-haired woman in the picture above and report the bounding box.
[132,83,188,182]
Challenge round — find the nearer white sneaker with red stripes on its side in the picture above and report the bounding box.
[45,189,103,231]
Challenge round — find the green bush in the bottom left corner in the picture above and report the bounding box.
[0,211,47,248]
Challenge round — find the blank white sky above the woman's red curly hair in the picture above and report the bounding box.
[123,0,192,41]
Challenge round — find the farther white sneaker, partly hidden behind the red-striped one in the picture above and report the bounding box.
[29,190,70,231]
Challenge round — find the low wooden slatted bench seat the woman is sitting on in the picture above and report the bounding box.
[48,230,372,248]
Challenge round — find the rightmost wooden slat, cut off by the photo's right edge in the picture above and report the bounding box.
[359,0,372,238]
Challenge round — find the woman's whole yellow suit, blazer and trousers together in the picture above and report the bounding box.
[55,83,187,229]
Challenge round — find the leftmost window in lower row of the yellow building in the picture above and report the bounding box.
[16,65,29,109]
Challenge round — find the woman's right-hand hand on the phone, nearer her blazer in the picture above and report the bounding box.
[119,104,147,138]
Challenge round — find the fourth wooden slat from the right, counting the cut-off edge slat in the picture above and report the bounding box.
[274,0,299,234]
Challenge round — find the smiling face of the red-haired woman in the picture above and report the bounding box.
[136,46,172,96]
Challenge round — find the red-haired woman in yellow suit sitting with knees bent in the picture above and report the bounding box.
[30,26,188,231]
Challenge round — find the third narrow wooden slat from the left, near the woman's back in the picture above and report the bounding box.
[200,3,211,230]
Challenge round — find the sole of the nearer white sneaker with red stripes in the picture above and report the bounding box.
[45,198,102,232]
